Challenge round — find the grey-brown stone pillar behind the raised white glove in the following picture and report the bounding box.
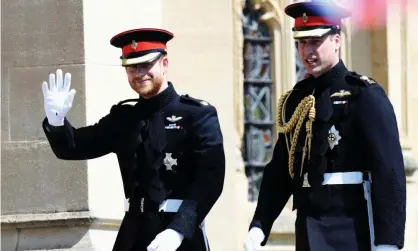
[1,0,89,250]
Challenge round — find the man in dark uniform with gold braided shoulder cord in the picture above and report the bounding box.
[244,1,406,251]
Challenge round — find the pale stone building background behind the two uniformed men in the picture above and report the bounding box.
[1,0,418,251]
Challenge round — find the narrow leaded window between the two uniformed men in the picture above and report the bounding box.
[242,0,274,201]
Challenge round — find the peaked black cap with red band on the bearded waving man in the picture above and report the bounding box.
[110,28,174,66]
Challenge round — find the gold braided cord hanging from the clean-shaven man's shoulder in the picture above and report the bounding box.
[276,91,316,178]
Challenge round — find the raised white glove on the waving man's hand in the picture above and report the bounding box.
[42,69,76,126]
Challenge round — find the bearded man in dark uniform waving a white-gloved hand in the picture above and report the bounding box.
[42,29,225,251]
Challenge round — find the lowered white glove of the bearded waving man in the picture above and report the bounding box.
[147,229,184,251]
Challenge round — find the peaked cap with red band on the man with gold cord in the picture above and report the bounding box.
[285,0,351,39]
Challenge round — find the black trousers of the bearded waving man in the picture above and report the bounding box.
[113,212,206,251]
